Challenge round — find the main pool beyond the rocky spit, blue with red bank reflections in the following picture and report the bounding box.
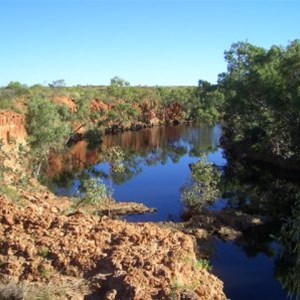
[48,125,225,221]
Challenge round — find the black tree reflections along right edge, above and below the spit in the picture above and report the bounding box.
[222,157,300,297]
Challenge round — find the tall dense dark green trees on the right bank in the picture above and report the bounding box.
[219,40,300,161]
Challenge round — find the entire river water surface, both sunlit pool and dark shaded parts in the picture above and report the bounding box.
[48,125,300,300]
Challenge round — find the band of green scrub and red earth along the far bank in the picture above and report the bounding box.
[0,77,222,144]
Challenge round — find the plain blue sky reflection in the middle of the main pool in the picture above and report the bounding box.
[114,149,225,222]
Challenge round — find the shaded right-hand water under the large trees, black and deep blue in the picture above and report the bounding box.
[218,156,300,300]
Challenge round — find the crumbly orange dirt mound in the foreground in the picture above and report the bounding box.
[0,194,226,300]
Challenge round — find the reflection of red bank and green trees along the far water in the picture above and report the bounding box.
[48,125,218,187]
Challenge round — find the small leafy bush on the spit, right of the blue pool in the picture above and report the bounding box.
[182,156,221,212]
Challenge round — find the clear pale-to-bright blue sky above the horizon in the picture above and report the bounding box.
[0,0,300,86]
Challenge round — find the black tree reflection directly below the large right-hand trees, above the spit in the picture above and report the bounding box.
[223,157,300,218]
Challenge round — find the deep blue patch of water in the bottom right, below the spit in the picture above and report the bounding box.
[211,240,288,300]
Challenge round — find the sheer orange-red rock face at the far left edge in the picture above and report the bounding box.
[0,111,26,144]
